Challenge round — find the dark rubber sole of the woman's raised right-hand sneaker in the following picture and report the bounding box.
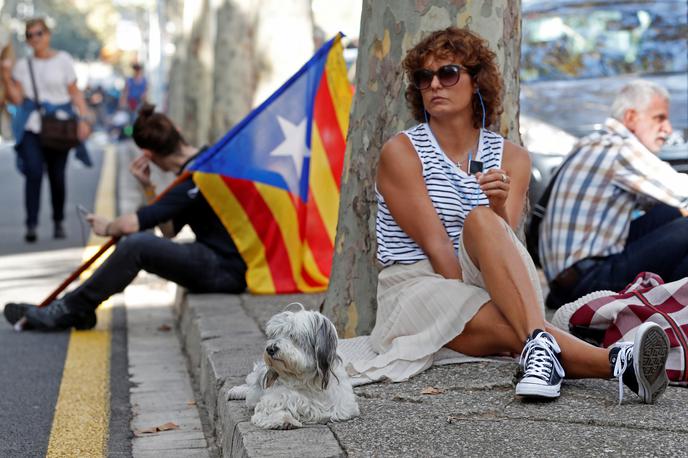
[633,323,669,404]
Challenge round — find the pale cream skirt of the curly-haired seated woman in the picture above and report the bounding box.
[340,222,544,384]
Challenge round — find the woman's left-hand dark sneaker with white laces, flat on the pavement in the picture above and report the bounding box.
[516,329,564,399]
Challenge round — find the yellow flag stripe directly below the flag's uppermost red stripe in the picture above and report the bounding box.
[309,126,339,240]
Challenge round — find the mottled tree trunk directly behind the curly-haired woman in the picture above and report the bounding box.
[324,0,521,337]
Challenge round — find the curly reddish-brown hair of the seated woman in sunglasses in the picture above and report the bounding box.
[401,27,503,128]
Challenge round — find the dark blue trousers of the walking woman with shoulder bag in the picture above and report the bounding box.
[17,131,69,227]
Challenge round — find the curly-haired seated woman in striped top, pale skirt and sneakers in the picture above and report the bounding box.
[348,27,668,403]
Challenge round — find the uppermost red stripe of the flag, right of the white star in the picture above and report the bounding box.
[313,70,346,187]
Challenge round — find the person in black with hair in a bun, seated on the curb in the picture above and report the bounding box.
[4,105,246,331]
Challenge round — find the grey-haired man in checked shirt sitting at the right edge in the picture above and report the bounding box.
[539,80,688,308]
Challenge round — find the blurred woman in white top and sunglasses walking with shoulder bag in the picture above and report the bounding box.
[2,19,94,242]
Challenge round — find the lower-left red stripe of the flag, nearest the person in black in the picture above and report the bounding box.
[222,176,298,293]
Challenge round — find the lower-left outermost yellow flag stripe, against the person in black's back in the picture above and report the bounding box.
[194,172,275,294]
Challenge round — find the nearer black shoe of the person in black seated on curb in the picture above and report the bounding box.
[19,299,96,331]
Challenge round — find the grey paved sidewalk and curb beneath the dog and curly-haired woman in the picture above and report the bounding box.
[176,294,688,457]
